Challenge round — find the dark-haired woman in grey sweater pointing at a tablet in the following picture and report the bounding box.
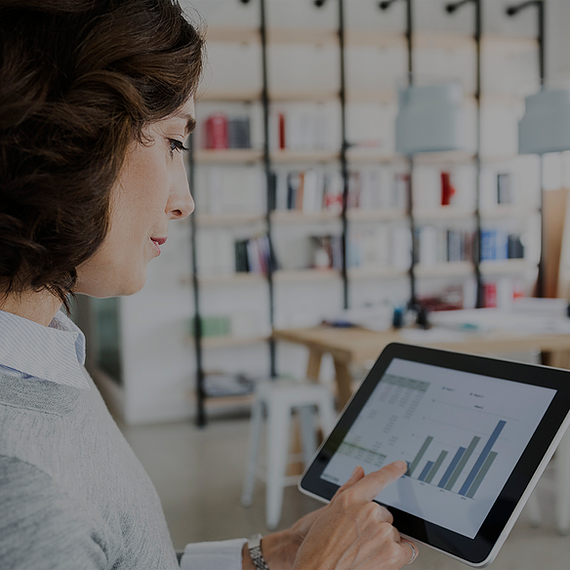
[0,0,416,570]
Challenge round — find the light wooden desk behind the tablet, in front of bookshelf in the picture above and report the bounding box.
[273,327,570,409]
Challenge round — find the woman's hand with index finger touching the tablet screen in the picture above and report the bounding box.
[294,461,417,570]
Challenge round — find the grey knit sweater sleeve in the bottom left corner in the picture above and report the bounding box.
[0,456,108,570]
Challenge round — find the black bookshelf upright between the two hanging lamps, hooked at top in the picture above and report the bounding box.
[445,0,485,308]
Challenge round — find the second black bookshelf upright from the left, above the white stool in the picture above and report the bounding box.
[259,0,277,378]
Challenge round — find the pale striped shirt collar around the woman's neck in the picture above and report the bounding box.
[0,311,89,390]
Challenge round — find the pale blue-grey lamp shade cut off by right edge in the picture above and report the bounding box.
[519,89,570,154]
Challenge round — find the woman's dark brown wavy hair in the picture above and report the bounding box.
[0,0,204,305]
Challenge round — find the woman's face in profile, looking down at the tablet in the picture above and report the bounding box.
[75,100,194,297]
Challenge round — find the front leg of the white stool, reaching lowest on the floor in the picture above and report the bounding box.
[265,403,291,530]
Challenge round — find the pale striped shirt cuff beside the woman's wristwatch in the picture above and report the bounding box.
[180,538,247,570]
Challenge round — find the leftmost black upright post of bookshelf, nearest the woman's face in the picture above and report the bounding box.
[188,135,207,427]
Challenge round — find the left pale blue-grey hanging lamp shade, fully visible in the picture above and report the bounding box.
[396,82,465,155]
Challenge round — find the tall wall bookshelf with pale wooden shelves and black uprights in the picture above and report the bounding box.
[189,2,538,421]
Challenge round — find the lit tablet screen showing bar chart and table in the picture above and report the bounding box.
[321,358,556,538]
